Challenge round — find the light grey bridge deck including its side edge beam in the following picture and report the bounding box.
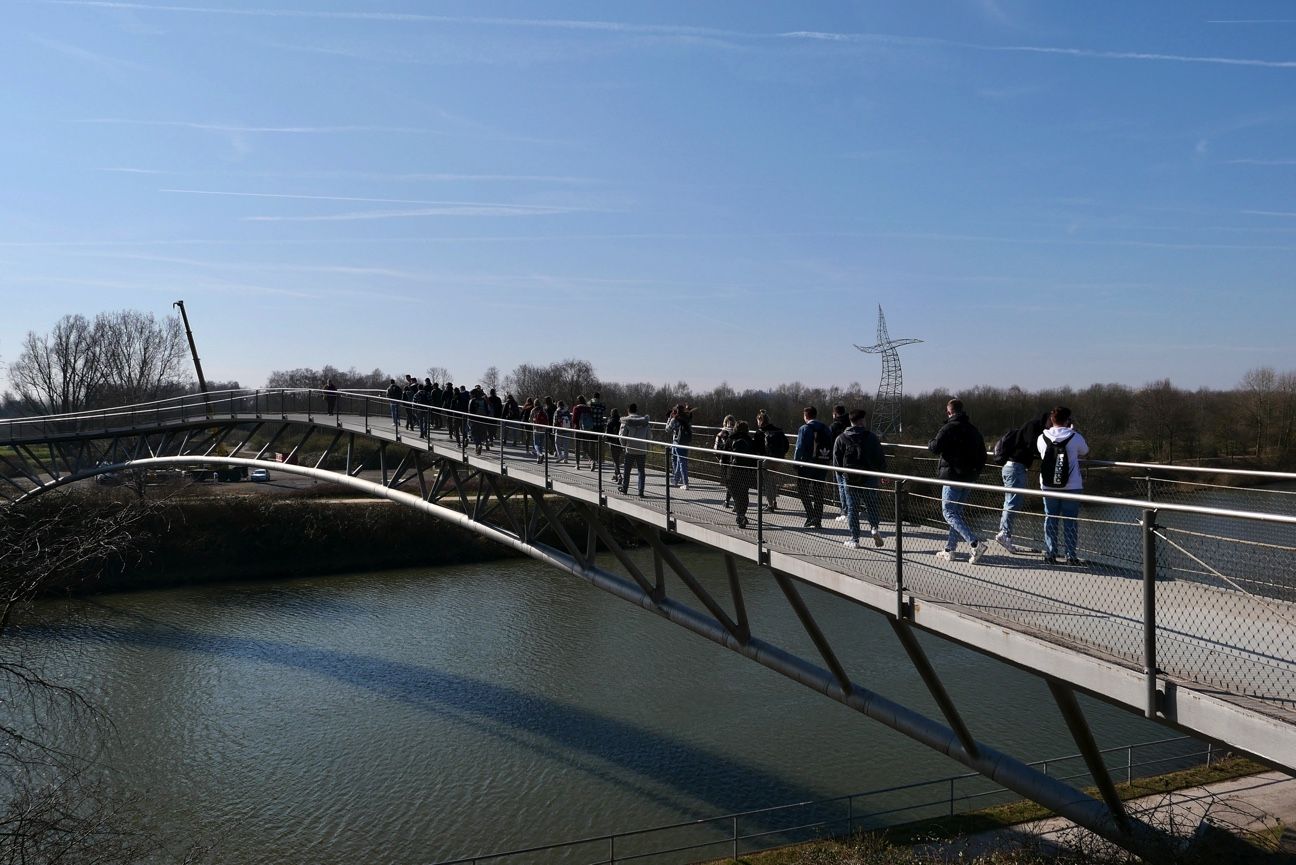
[5,412,1296,766]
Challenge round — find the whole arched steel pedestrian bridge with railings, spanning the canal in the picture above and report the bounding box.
[0,390,1296,847]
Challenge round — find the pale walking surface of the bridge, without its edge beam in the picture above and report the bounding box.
[289,416,1296,724]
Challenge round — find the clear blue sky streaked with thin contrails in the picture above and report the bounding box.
[0,0,1296,392]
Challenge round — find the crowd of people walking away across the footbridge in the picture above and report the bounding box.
[352,375,1089,564]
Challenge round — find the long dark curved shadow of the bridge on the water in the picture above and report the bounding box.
[21,610,839,840]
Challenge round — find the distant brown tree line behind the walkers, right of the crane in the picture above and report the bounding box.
[257,358,1296,467]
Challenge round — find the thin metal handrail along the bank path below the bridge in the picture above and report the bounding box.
[435,737,1213,865]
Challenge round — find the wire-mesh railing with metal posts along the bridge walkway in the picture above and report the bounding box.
[0,390,1296,707]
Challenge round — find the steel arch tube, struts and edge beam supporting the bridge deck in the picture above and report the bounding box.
[0,393,1296,851]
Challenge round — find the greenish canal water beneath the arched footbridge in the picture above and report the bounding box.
[22,549,1170,864]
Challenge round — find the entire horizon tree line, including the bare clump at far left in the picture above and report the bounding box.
[0,310,1296,467]
